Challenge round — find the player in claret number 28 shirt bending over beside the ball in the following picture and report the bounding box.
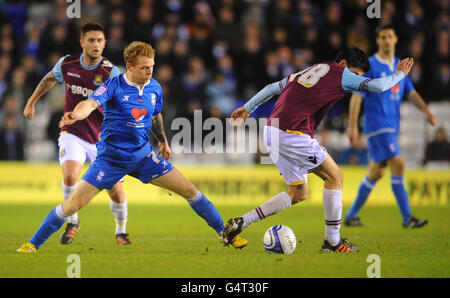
[222,47,414,252]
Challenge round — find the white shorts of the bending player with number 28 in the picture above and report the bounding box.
[264,126,327,185]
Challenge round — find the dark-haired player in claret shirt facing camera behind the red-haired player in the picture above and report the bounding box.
[23,23,131,245]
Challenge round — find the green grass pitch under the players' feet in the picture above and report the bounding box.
[0,202,450,278]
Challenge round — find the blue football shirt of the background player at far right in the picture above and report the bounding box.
[360,54,414,137]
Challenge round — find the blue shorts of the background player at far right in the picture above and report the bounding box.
[367,133,402,163]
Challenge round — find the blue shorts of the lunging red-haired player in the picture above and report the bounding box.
[81,150,173,189]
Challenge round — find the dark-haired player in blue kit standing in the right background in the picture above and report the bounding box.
[344,25,436,228]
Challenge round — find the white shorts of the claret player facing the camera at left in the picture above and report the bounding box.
[58,133,97,166]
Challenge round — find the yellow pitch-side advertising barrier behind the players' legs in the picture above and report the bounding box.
[0,162,450,206]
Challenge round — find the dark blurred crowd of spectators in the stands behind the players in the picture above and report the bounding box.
[0,0,450,164]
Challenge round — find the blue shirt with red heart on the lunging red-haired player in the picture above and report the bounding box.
[89,74,163,163]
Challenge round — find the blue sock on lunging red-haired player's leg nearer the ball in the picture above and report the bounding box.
[188,191,225,234]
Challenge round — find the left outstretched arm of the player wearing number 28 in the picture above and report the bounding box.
[230,78,287,126]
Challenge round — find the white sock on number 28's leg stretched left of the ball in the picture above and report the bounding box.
[242,192,292,229]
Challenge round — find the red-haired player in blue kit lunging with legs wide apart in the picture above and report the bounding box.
[17,42,247,253]
